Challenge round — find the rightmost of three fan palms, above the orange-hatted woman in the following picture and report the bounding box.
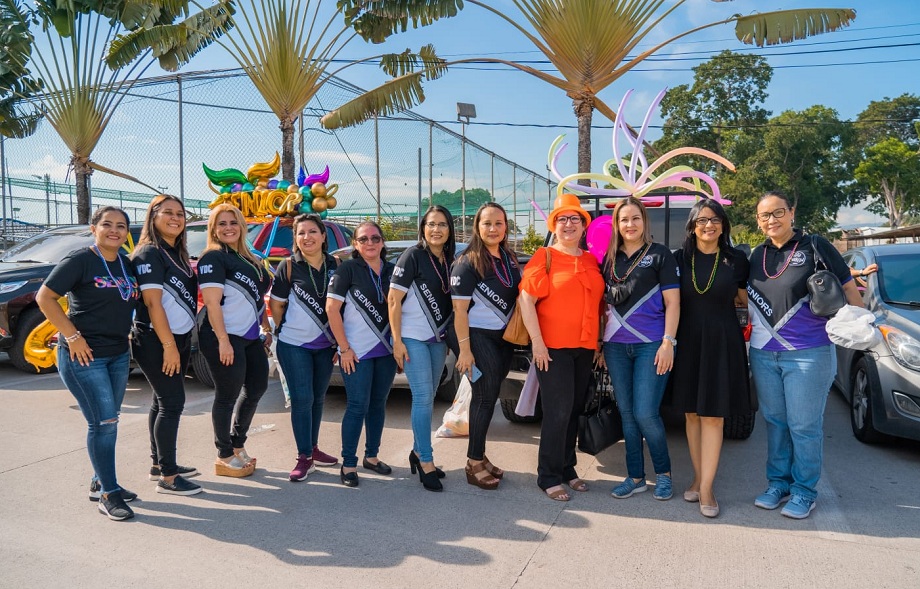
[322,0,856,182]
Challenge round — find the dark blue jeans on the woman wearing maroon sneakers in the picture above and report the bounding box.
[278,341,335,456]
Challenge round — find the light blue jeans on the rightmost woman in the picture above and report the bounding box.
[750,345,837,500]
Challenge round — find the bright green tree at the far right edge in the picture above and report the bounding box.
[854,137,920,229]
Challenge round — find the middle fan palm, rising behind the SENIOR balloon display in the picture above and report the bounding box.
[107,0,444,180]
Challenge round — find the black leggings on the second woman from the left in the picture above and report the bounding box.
[131,323,192,476]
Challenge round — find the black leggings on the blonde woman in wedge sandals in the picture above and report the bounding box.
[198,321,268,458]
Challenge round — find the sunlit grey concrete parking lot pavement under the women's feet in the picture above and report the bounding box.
[0,357,920,589]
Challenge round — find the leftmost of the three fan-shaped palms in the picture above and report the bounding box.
[0,0,231,223]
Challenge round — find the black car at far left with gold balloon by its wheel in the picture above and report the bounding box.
[0,225,141,374]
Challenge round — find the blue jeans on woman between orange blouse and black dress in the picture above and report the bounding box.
[604,342,671,479]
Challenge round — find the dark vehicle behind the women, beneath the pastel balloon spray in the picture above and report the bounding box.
[499,197,758,440]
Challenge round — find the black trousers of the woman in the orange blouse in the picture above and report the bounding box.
[537,348,594,490]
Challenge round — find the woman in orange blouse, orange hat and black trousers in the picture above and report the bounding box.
[518,194,604,501]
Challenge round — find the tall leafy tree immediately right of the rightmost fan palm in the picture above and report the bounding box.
[655,50,773,171]
